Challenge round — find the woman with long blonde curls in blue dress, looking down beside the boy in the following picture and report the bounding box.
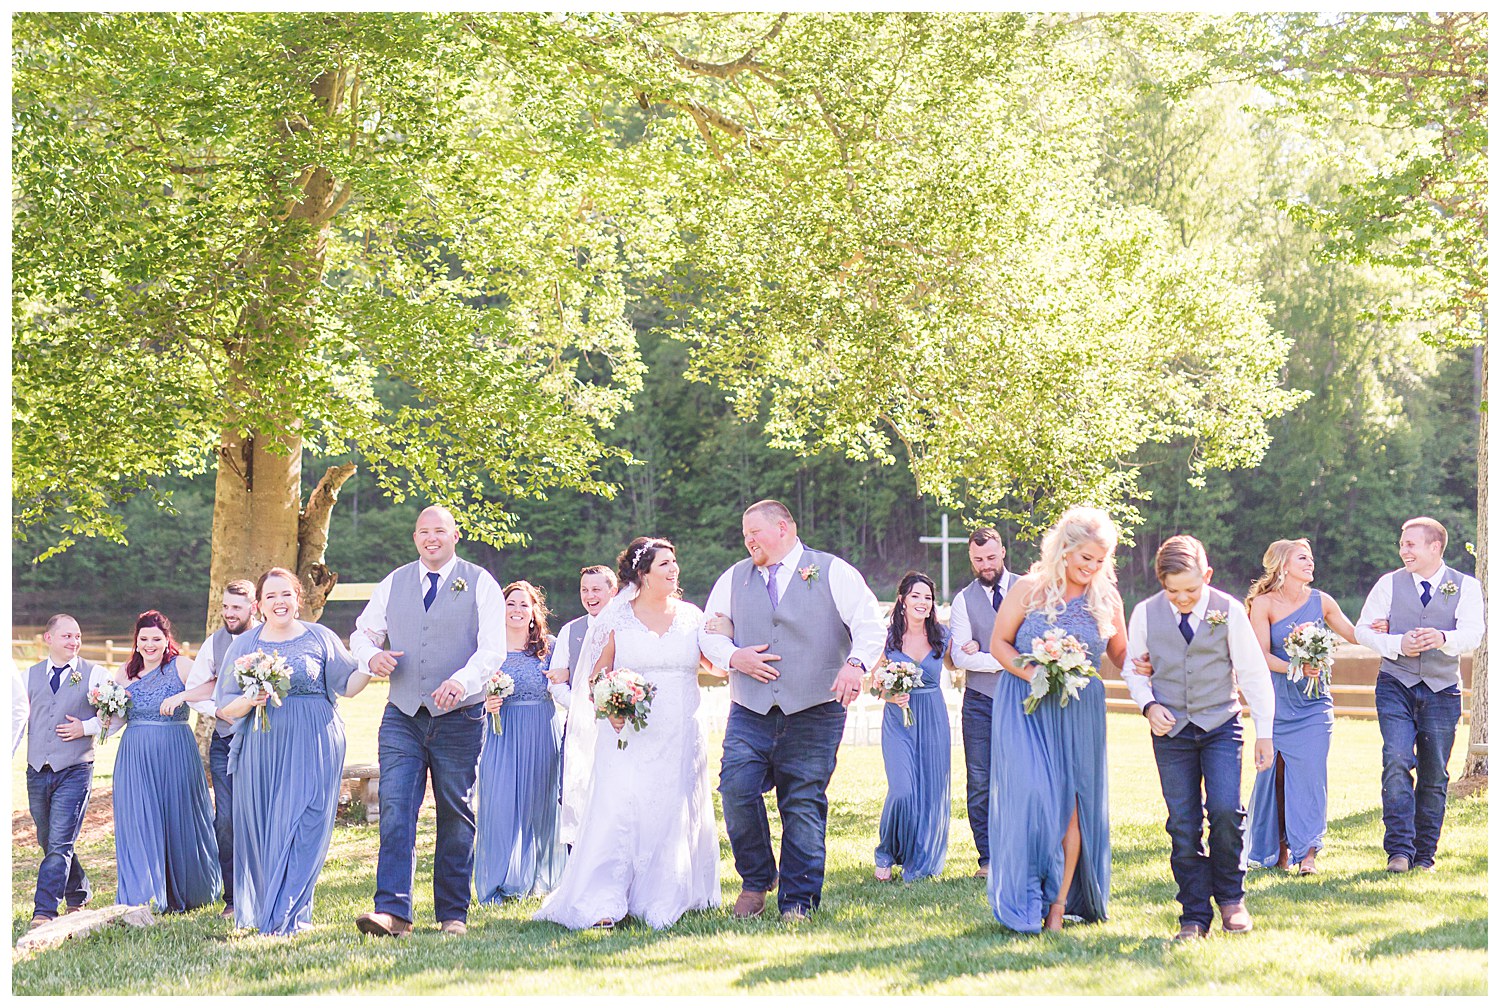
[989,507,1125,933]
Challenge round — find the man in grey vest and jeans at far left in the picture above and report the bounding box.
[26,614,110,927]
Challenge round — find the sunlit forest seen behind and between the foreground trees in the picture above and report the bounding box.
[12,15,1485,639]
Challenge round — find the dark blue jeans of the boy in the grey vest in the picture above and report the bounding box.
[1151,717,1245,930]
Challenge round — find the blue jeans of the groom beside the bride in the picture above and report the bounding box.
[719,701,848,914]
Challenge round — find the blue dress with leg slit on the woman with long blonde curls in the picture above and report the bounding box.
[989,596,1110,933]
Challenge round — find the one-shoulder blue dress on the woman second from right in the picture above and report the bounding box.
[1245,588,1334,869]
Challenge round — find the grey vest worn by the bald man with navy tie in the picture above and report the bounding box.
[386,560,485,717]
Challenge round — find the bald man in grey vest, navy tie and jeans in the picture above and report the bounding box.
[350,507,506,938]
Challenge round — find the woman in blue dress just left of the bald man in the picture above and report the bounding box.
[218,567,369,935]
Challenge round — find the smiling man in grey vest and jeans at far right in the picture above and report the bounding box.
[1355,518,1485,872]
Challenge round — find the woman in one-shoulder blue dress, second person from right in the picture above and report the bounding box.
[1245,539,1355,875]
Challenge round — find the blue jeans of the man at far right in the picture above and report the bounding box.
[1376,672,1463,866]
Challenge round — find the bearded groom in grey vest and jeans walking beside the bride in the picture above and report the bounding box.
[699,501,885,921]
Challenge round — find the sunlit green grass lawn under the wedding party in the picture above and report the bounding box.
[11,690,1488,995]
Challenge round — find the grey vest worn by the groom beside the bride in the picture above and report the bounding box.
[729,546,852,714]
